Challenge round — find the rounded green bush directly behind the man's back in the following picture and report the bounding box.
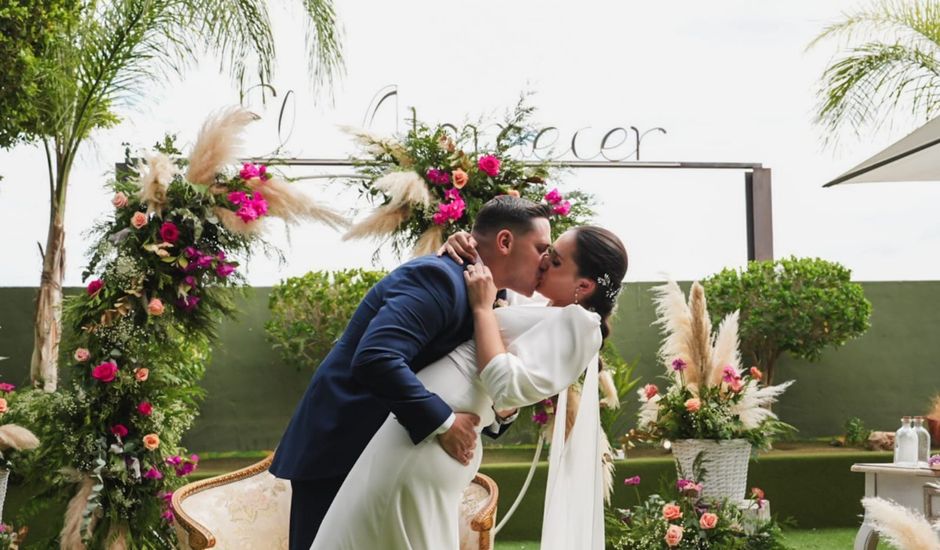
[264,269,385,370]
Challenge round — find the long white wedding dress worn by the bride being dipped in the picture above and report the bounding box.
[311,305,604,550]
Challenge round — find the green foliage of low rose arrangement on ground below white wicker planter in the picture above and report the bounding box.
[605,478,788,550]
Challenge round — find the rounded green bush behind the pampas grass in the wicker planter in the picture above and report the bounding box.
[703,257,871,384]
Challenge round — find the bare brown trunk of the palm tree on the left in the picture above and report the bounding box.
[30,215,65,392]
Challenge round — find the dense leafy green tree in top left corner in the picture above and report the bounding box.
[0,0,78,149]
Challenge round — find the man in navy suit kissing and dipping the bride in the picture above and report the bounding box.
[270,195,551,550]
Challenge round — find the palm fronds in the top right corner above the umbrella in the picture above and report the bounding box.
[809,0,940,141]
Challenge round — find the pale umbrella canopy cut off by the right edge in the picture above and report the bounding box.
[823,117,940,187]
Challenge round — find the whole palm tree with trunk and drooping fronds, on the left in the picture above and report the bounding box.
[31,0,342,391]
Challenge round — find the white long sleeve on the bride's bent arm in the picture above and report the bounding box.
[480,305,601,410]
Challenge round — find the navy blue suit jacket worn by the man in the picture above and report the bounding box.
[270,256,473,480]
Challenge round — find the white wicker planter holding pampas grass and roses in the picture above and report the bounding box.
[672,439,751,501]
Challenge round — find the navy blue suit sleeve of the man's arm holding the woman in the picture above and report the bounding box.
[352,265,463,444]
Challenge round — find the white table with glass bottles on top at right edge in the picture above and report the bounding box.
[852,463,940,550]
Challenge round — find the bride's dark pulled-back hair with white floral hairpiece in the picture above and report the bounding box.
[573,225,627,340]
